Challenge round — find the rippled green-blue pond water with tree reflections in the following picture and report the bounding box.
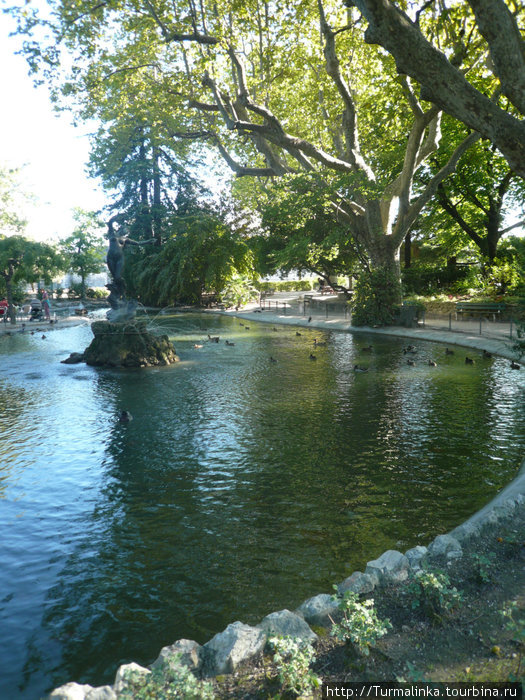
[0,314,525,700]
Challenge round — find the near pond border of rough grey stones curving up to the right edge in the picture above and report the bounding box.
[48,460,525,700]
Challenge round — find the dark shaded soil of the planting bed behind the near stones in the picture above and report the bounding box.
[214,506,525,699]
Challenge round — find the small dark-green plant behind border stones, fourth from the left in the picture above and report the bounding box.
[406,569,463,620]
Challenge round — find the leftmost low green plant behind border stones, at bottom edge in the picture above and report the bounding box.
[119,660,215,700]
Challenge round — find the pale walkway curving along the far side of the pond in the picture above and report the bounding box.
[213,293,520,361]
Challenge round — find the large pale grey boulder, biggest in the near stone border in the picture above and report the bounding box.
[203,622,266,677]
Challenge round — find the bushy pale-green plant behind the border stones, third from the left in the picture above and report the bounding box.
[331,591,392,656]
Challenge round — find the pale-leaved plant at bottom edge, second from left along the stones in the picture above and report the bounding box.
[268,637,321,695]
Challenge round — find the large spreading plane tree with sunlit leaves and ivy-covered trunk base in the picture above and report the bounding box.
[8,0,479,323]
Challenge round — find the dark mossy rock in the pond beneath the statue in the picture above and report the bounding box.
[84,320,179,367]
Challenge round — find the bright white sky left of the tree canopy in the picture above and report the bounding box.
[0,7,105,241]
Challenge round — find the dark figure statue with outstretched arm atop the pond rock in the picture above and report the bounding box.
[106,215,155,323]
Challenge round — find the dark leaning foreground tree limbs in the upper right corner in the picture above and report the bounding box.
[345,0,525,177]
